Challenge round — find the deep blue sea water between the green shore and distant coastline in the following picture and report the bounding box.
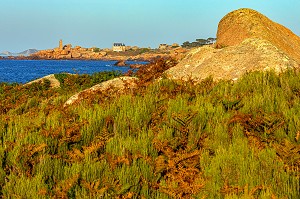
[0,60,145,83]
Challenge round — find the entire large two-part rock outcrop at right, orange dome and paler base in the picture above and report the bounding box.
[166,9,300,81]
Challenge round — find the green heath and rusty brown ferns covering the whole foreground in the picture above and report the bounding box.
[0,61,300,198]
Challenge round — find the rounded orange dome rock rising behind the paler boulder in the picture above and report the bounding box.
[216,8,300,63]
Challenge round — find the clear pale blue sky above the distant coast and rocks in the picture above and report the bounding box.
[0,0,300,52]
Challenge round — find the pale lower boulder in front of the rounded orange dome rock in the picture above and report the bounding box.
[166,38,299,81]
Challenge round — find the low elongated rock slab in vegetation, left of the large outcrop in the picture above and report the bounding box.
[64,77,138,107]
